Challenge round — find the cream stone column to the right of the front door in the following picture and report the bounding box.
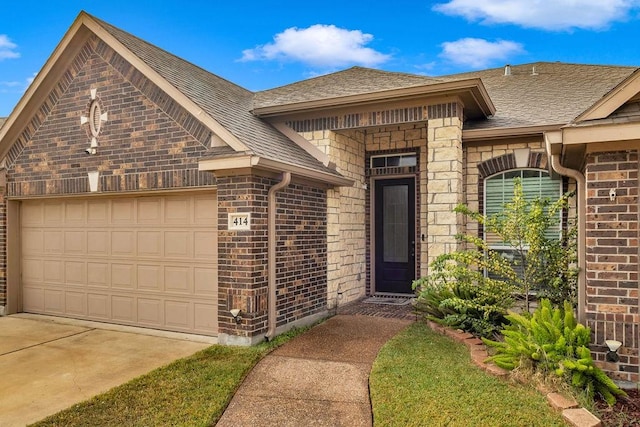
[426,104,464,263]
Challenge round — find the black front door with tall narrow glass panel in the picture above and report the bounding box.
[374,178,416,294]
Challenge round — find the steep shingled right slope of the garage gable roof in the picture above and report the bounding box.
[91,16,339,175]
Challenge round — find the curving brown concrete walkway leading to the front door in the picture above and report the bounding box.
[217,315,411,427]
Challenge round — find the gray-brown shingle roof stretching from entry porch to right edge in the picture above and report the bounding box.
[254,62,635,129]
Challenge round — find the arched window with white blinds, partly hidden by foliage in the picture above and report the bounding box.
[484,169,562,278]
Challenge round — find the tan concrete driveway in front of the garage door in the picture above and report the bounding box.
[0,315,211,427]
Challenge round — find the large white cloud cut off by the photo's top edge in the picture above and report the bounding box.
[433,0,640,31]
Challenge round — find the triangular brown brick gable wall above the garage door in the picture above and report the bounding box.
[6,37,214,196]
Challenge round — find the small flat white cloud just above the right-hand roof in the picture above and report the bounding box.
[440,38,524,68]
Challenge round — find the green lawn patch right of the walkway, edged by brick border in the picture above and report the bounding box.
[370,323,565,427]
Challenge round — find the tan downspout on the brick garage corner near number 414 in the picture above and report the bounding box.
[265,172,291,341]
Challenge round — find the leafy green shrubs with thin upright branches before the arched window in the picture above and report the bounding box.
[414,179,577,336]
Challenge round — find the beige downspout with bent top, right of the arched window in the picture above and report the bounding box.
[547,140,587,325]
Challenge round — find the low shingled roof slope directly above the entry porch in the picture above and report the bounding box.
[254,67,443,108]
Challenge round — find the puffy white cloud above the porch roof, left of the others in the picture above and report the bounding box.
[241,24,391,67]
